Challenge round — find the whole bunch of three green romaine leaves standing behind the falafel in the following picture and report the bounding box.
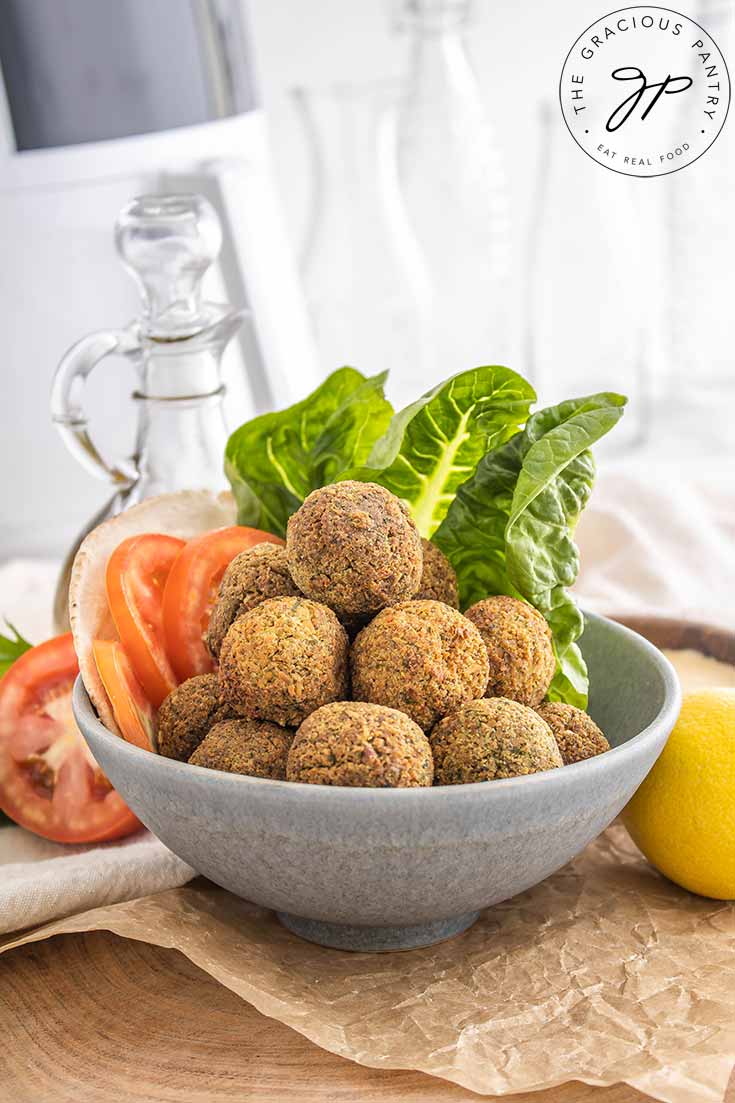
[225,366,626,708]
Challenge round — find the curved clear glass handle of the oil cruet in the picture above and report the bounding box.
[51,330,138,490]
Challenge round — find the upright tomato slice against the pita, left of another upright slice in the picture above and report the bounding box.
[105,533,184,708]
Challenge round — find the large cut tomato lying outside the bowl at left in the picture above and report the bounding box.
[0,633,140,843]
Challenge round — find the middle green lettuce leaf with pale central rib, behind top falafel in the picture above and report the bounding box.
[345,365,536,537]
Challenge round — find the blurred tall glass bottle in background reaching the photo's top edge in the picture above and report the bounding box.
[394,0,510,375]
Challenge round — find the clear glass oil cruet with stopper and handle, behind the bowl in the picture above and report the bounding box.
[51,195,246,632]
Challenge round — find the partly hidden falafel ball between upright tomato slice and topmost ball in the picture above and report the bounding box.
[206,540,299,658]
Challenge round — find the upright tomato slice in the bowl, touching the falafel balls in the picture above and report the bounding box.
[163,525,284,682]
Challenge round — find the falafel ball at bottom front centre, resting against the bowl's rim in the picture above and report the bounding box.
[286,700,434,789]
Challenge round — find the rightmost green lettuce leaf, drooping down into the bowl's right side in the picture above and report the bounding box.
[434,394,626,708]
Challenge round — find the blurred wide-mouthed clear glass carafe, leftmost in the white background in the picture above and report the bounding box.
[292,82,422,401]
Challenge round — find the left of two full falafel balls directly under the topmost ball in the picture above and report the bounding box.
[220,598,348,727]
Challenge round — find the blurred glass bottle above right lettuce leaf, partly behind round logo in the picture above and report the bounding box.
[521,103,656,449]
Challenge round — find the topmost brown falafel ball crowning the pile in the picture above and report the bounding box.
[286,481,424,623]
